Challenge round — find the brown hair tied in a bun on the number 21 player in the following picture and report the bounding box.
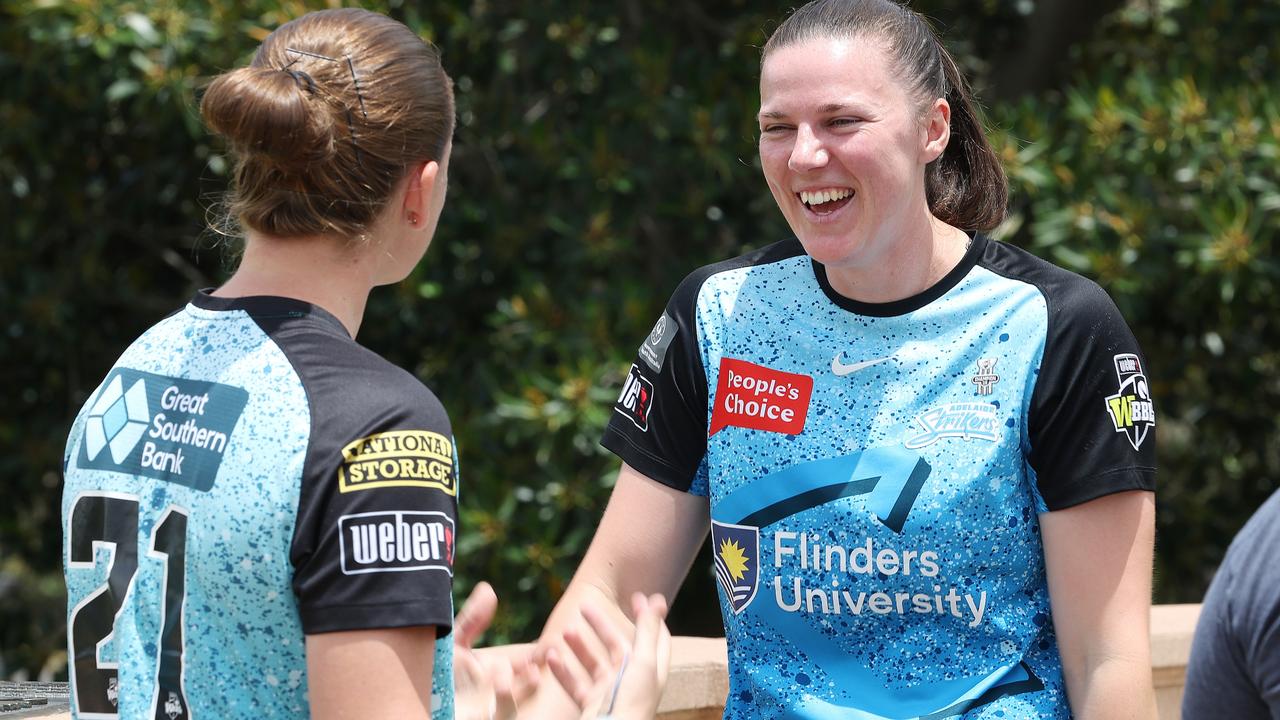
[200,9,453,238]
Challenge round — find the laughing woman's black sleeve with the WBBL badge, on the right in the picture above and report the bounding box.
[1028,269,1156,510]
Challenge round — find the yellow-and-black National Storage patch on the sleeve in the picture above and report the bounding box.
[338,430,457,495]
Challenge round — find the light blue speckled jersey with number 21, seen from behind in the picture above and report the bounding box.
[61,293,456,720]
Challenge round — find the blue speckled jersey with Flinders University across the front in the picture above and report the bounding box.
[604,237,1155,719]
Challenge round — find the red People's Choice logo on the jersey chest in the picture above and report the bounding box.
[707,357,813,437]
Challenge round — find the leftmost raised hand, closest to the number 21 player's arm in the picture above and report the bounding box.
[453,582,541,720]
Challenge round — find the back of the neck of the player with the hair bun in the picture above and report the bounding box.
[214,231,375,337]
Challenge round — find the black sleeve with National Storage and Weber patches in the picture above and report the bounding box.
[291,333,457,637]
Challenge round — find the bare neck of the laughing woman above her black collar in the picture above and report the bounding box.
[826,215,969,302]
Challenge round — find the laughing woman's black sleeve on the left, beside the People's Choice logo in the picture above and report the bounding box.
[600,266,708,491]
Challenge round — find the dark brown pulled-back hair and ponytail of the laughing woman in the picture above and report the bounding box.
[762,0,1009,231]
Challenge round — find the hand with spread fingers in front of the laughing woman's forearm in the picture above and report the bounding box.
[547,593,671,720]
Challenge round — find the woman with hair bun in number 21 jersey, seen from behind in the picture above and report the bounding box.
[63,9,524,720]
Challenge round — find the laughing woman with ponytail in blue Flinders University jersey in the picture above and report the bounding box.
[531,0,1156,720]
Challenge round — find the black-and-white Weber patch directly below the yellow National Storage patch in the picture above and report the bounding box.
[338,512,454,578]
